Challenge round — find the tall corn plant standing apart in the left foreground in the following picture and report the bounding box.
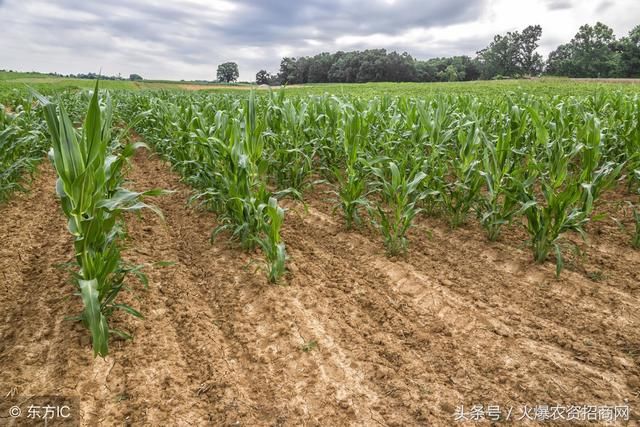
[39,82,161,357]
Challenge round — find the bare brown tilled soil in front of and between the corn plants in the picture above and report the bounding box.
[0,153,640,426]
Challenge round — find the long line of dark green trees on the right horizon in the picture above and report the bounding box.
[256,22,640,85]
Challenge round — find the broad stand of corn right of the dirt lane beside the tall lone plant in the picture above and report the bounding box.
[116,91,640,273]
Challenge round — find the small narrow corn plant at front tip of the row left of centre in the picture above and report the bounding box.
[256,197,287,283]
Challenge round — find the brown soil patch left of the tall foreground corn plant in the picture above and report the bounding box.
[0,161,115,420]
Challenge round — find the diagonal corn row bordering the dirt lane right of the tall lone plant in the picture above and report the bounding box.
[122,92,290,282]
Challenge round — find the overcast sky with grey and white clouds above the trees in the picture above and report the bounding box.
[0,0,640,80]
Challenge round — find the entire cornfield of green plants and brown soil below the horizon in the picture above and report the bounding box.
[0,74,640,426]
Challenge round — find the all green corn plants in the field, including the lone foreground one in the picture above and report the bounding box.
[0,80,640,356]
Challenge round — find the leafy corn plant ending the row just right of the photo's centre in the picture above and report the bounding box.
[370,161,427,256]
